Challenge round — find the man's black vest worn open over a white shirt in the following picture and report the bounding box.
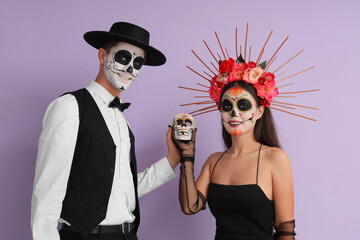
[61,88,140,237]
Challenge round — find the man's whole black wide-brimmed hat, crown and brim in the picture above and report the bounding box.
[84,22,166,66]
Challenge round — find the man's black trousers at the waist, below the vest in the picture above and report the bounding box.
[59,229,138,240]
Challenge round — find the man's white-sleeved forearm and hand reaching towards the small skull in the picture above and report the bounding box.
[138,127,180,197]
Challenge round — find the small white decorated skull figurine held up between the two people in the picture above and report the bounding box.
[173,113,195,141]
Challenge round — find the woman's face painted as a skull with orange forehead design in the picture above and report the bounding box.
[221,87,261,135]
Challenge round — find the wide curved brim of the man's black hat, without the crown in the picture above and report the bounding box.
[84,31,166,66]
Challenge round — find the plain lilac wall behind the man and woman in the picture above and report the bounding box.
[0,0,360,240]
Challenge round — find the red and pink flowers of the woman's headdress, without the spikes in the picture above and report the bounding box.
[209,54,279,109]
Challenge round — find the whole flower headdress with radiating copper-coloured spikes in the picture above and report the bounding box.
[179,24,320,121]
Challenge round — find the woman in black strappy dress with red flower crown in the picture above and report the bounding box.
[173,55,295,240]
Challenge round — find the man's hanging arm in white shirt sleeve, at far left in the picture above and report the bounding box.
[31,94,79,240]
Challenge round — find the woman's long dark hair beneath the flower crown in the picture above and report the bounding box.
[220,81,280,148]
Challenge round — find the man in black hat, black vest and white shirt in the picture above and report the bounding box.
[31,22,180,240]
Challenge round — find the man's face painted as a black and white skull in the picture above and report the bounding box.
[104,42,145,91]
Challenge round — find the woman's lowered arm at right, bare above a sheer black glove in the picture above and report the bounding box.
[272,149,295,240]
